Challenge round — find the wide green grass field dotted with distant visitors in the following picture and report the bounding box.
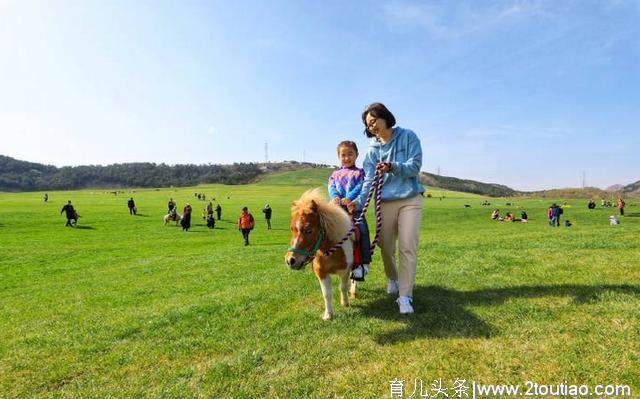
[0,170,640,398]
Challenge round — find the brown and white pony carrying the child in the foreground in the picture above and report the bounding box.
[284,188,357,320]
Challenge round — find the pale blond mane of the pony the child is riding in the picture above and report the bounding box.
[291,187,351,242]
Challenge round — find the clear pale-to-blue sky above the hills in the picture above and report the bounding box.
[0,0,640,189]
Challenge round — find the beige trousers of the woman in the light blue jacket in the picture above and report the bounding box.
[380,194,424,297]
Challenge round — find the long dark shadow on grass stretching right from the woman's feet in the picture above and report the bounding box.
[363,285,640,345]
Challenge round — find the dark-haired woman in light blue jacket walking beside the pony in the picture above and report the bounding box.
[350,103,424,314]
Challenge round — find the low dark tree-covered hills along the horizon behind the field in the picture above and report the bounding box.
[0,155,640,198]
